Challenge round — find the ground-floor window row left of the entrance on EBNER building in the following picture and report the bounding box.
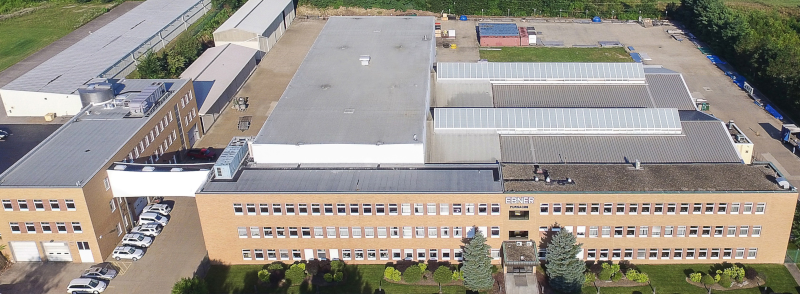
[242,249,500,260]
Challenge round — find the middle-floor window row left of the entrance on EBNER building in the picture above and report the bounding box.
[237,227,500,238]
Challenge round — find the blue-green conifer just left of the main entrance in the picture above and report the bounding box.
[461,228,494,291]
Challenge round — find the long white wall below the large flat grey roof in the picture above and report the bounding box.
[252,142,425,164]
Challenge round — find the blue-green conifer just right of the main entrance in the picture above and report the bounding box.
[547,230,586,293]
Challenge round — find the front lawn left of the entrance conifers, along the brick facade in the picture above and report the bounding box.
[206,264,466,294]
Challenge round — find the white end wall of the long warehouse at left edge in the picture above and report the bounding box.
[0,89,83,116]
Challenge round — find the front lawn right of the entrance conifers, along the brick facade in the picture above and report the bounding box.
[583,264,800,294]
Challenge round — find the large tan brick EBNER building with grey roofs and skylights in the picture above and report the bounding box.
[196,17,797,264]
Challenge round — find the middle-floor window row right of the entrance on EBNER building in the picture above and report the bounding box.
[564,226,761,238]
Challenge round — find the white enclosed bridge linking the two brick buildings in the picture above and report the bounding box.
[107,170,211,197]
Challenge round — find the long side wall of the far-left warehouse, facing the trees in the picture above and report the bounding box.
[99,0,211,79]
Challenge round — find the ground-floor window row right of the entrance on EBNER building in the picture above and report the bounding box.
[586,248,758,260]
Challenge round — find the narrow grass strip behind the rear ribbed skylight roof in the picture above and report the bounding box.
[480,47,633,62]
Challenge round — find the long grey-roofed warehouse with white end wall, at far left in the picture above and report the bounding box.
[0,0,211,116]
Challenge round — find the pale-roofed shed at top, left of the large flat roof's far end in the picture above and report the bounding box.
[214,0,295,59]
